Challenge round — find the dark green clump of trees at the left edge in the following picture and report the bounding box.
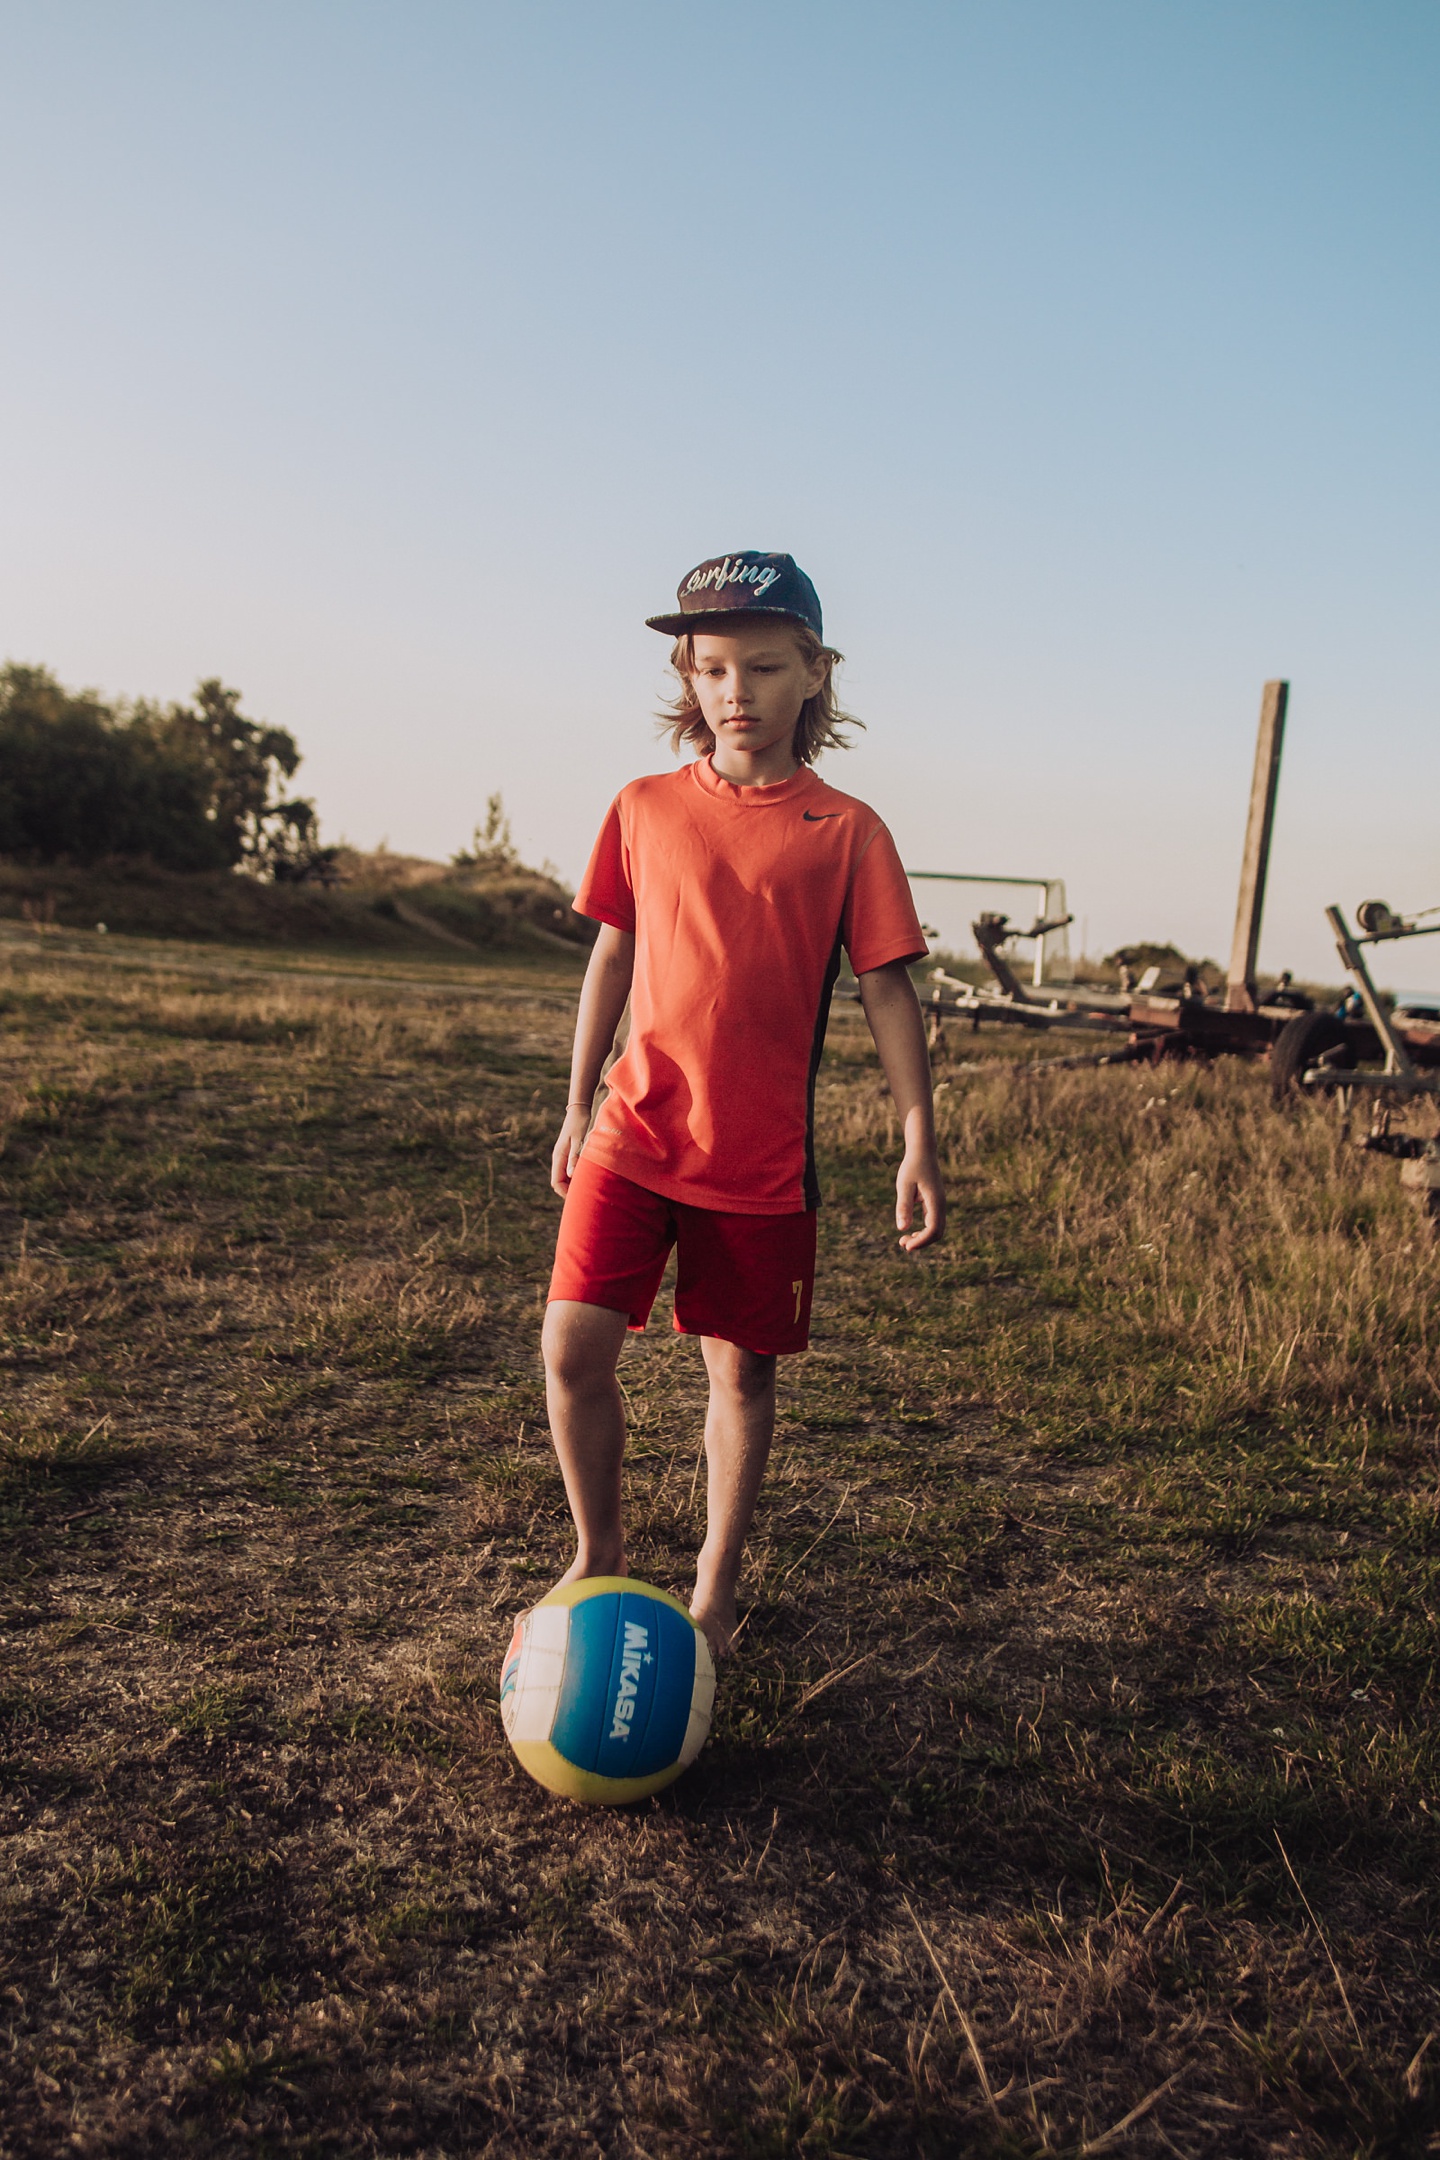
[0,663,337,881]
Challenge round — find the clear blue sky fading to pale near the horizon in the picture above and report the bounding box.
[0,0,1440,985]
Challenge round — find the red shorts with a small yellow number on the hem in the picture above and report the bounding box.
[551,1156,816,1356]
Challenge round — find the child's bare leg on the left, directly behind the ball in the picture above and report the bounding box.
[540,1298,628,1588]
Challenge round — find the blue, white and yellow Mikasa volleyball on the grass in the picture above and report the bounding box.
[501,1575,715,1806]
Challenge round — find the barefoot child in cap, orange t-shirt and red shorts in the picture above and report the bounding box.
[544,549,946,1657]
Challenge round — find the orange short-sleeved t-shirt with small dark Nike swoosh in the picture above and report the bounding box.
[574,758,926,1214]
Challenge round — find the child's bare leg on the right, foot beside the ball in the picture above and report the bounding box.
[691,1335,775,1657]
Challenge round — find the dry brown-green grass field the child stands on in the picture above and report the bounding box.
[0,933,1440,2160]
